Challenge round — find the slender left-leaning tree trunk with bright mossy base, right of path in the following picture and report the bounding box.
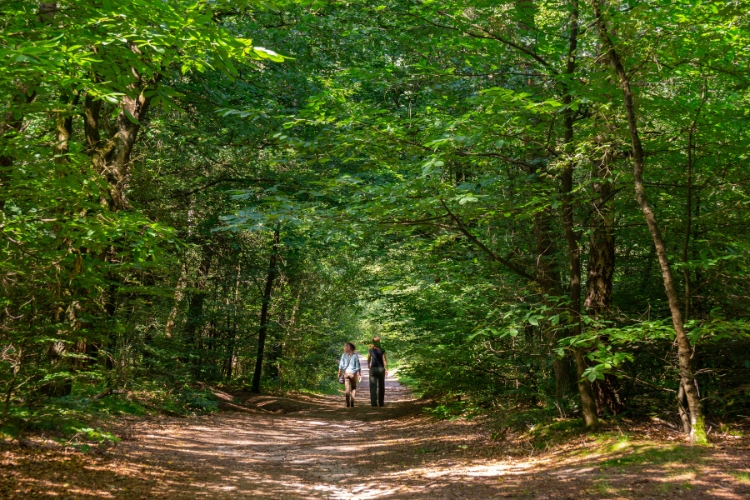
[591,0,708,444]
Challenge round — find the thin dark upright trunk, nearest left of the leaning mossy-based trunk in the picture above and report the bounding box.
[562,0,599,430]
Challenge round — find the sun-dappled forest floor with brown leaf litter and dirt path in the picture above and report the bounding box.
[0,362,750,499]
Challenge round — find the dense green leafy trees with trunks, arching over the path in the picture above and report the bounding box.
[0,0,750,441]
